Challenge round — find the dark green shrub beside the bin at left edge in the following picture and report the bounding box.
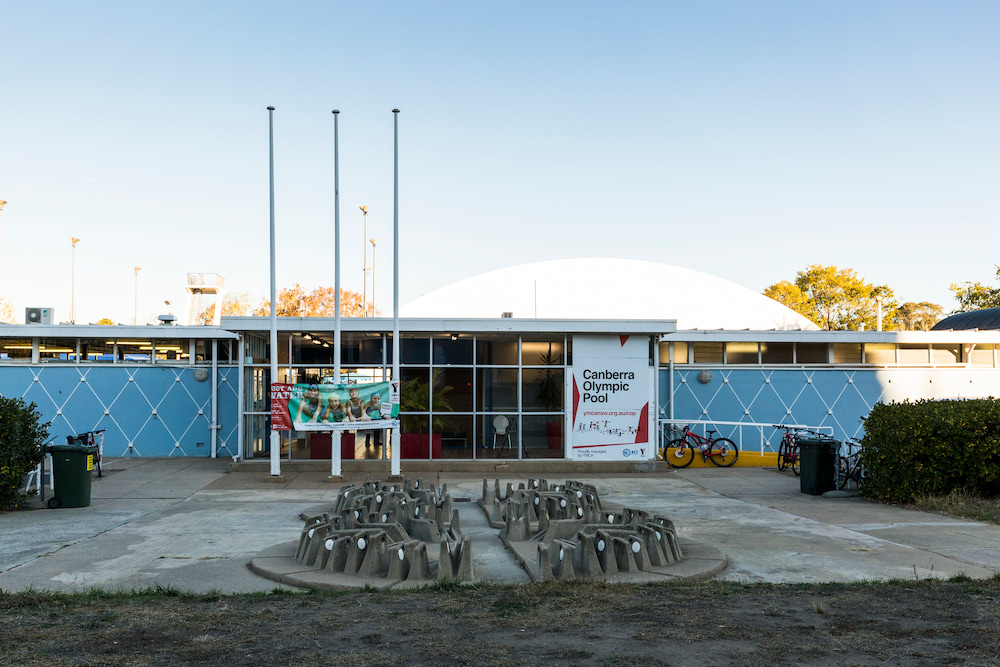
[0,396,49,510]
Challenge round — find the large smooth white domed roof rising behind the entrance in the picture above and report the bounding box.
[400,259,819,331]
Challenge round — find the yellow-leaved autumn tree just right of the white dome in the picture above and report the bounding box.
[764,264,897,330]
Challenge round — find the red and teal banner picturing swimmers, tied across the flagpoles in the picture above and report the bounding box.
[271,382,399,431]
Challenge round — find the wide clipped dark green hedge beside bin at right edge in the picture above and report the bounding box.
[862,398,1000,503]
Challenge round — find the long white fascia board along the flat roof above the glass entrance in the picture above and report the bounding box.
[222,317,677,335]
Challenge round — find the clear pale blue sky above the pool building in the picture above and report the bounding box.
[0,0,1000,322]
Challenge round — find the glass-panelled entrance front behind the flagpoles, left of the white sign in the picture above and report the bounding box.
[244,331,572,460]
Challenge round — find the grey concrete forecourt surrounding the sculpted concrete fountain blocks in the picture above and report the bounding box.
[0,458,1000,593]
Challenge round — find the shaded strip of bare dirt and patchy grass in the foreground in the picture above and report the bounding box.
[0,577,1000,667]
